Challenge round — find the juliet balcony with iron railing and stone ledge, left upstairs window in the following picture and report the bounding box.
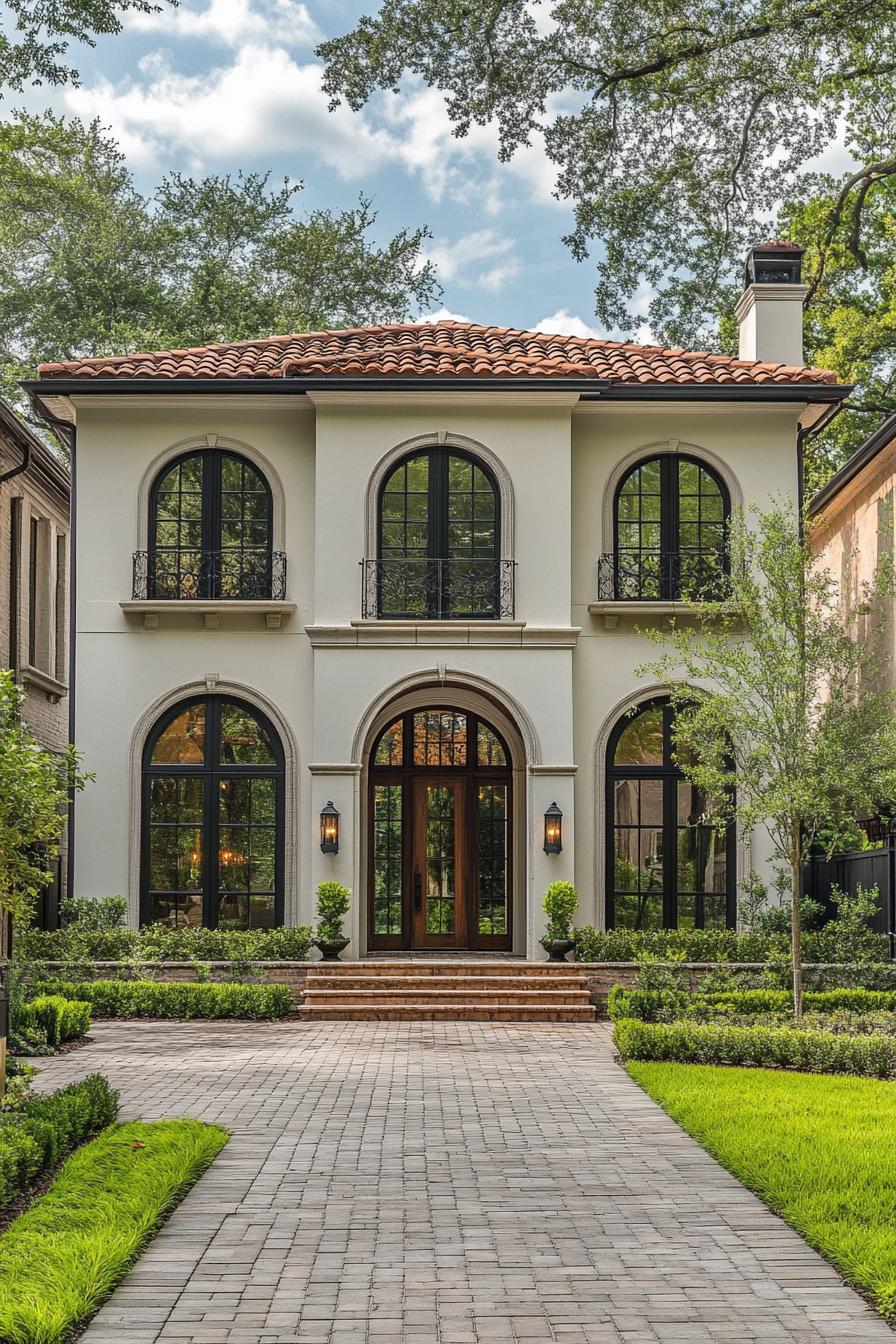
[121,547,296,629]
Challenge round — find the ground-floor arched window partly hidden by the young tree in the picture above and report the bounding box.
[606,700,736,929]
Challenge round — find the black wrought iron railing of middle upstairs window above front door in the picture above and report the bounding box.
[361,555,514,621]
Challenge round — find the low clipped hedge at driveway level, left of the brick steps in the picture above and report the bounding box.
[38,980,293,1021]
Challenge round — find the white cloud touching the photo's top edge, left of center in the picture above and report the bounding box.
[125,0,322,47]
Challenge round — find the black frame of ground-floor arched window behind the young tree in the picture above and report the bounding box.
[604,696,737,929]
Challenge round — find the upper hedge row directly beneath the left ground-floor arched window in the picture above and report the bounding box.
[16,925,312,961]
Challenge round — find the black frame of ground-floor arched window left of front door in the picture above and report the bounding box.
[140,694,286,929]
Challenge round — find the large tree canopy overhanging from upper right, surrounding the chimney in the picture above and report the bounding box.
[318,0,896,467]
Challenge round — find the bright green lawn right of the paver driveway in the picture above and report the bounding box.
[627,1063,896,1318]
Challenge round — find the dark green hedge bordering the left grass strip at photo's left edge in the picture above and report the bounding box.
[0,1074,118,1208]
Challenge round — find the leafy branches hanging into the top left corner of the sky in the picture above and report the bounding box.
[0,0,177,90]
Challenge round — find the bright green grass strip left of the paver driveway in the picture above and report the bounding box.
[0,1120,228,1344]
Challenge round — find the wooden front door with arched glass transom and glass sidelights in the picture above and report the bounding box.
[368,708,512,950]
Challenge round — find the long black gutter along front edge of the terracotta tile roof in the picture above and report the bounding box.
[21,375,853,402]
